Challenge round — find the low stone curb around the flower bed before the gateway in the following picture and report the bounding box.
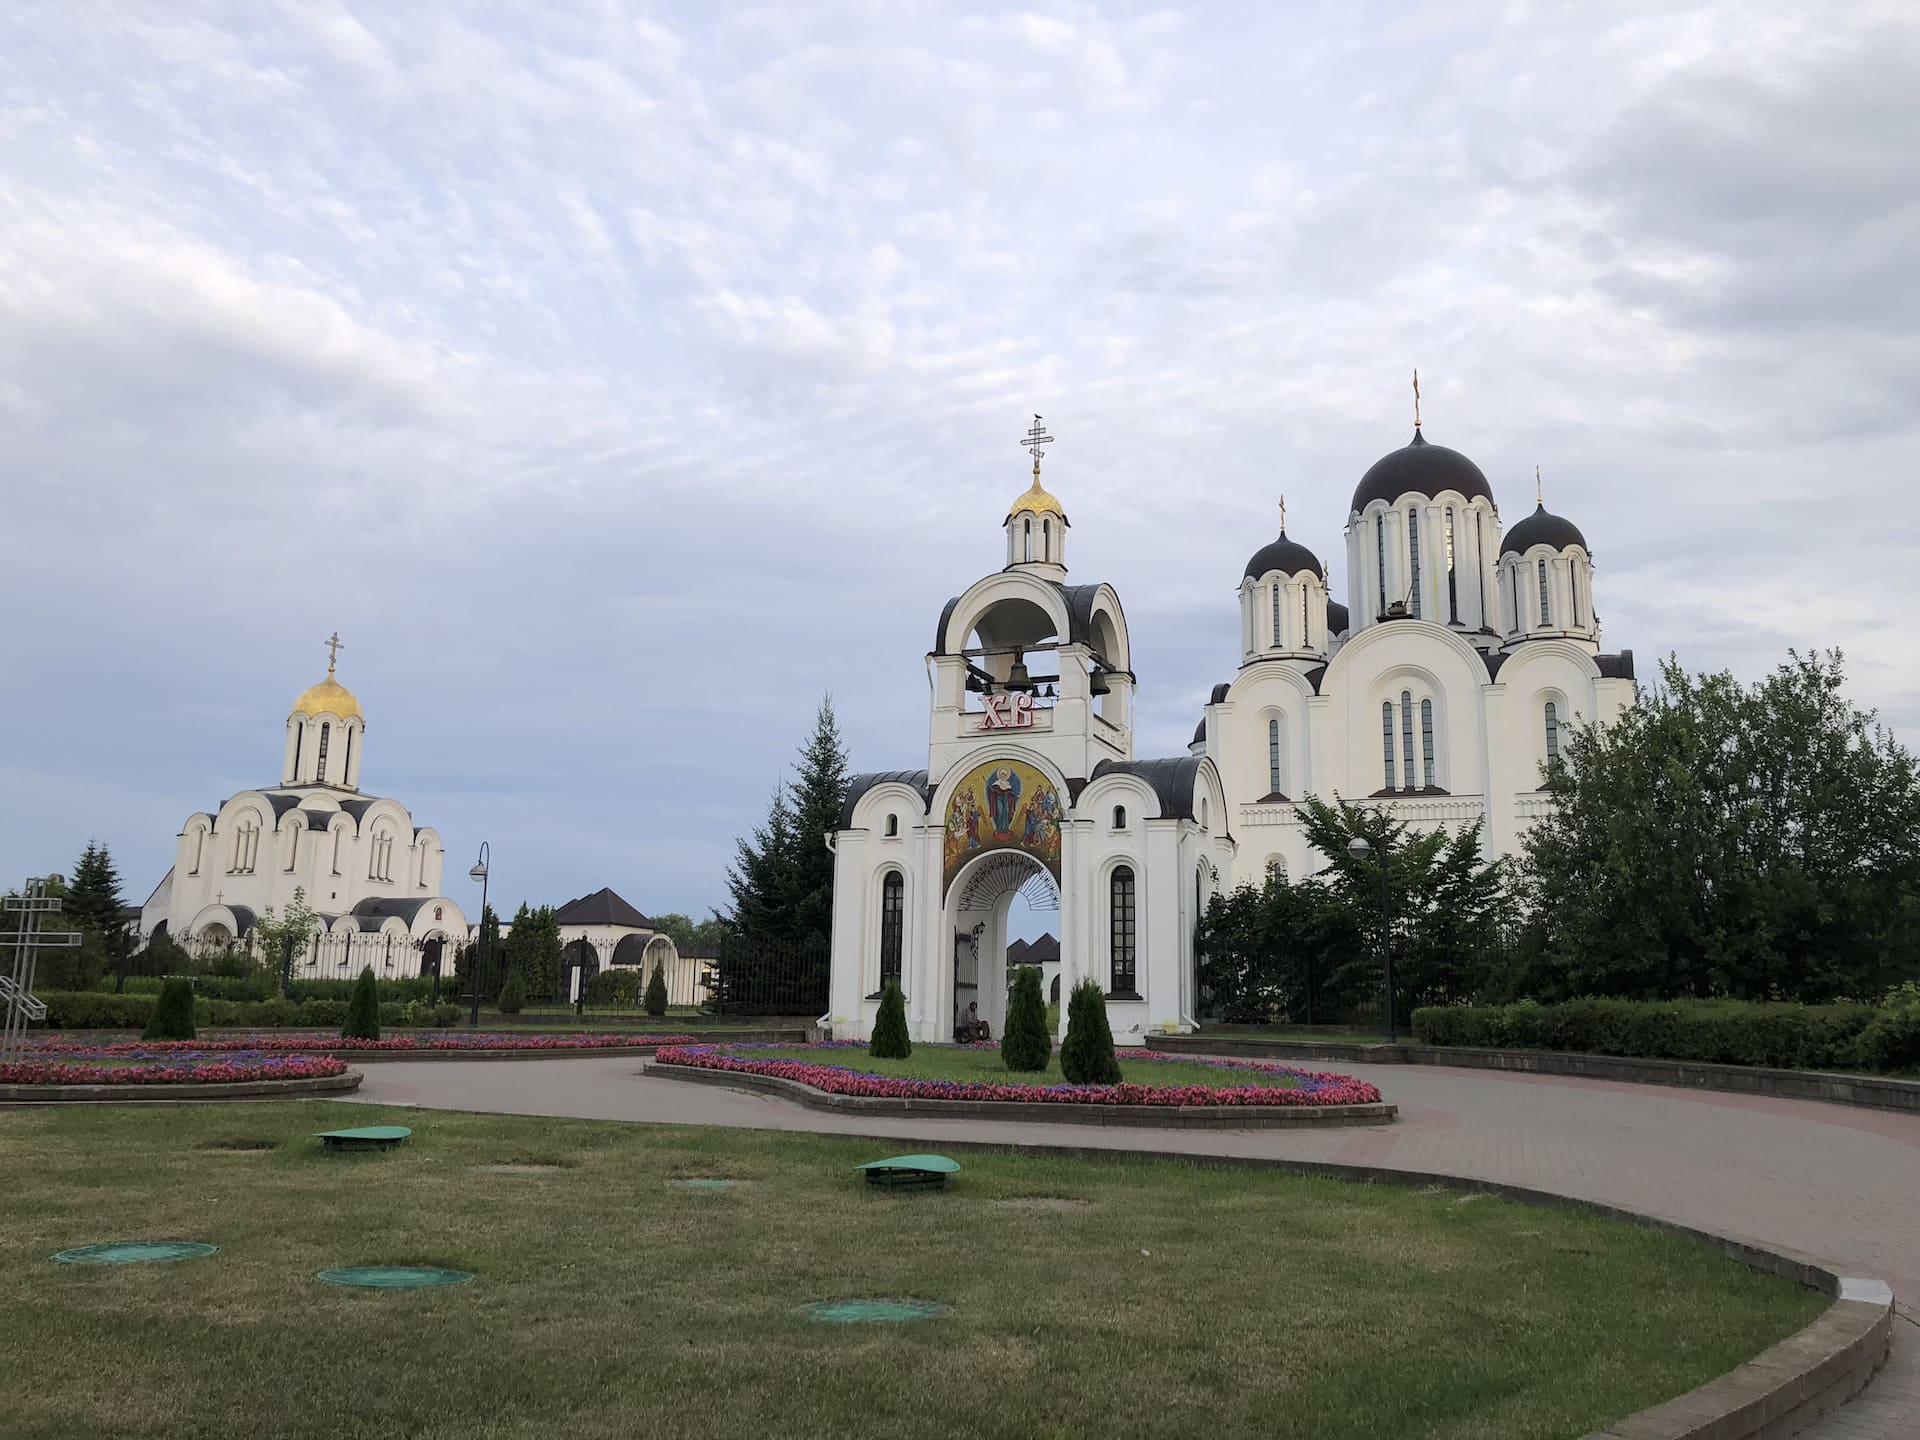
[639,1062,1400,1129]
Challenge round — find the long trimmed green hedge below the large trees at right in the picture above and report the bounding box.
[1413,998,1905,1069]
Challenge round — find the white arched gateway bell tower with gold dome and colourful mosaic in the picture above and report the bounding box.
[828,428,1235,1044]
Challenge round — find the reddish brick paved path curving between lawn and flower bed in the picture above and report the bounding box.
[359,1058,1920,1440]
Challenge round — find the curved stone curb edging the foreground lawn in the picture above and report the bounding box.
[768,1136,1893,1440]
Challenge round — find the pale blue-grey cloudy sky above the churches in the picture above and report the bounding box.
[0,0,1920,914]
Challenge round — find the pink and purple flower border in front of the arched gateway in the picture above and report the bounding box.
[655,1041,1380,1108]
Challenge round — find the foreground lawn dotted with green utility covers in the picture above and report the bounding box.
[0,1102,1824,1440]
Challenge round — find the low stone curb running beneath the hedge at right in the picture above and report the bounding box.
[1146,1035,1920,1114]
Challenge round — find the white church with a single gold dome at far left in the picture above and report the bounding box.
[140,636,467,977]
